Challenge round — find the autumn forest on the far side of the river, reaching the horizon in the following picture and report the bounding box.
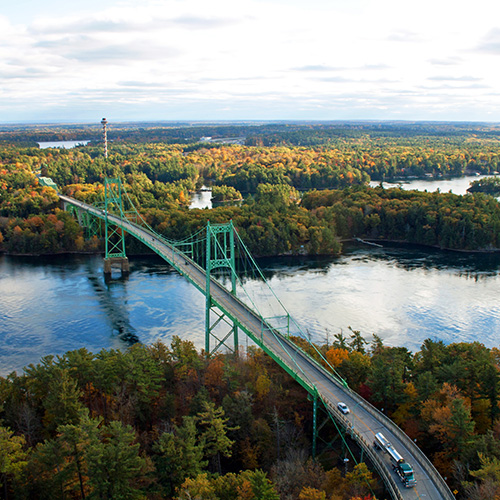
[0,120,500,256]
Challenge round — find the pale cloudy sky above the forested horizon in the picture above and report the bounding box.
[0,0,500,124]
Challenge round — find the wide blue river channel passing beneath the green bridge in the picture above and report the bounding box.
[0,245,500,375]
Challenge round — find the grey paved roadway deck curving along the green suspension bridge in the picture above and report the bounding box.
[60,195,455,500]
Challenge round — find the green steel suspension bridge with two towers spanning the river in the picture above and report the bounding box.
[59,179,455,500]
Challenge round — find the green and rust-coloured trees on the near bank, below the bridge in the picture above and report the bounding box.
[0,336,500,500]
